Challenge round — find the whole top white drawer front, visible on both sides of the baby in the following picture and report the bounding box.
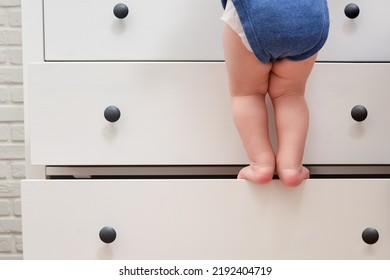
[44,0,390,61]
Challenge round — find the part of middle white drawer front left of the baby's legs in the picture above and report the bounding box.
[29,63,246,165]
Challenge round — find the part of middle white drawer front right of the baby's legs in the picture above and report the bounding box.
[304,63,390,164]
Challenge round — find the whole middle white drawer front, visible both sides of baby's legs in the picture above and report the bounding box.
[29,63,390,165]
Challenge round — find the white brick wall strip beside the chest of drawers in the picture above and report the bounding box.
[0,0,25,259]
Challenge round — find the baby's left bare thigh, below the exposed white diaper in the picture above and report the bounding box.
[223,24,272,96]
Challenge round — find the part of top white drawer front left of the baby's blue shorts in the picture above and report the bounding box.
[44,0,223,60]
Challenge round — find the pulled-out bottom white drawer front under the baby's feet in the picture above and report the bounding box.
[22,180,390,259]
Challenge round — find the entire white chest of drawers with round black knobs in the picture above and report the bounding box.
[22,0,390,259]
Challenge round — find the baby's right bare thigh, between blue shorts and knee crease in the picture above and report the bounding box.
[269,55,317,98]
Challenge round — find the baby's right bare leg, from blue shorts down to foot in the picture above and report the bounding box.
[269,55,316,186]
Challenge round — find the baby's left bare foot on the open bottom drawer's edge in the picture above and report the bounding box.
[237,164,275,185]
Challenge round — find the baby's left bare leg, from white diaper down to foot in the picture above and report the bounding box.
[223,25,275,184]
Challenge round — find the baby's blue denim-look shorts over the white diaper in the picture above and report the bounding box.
[222,0,329,63]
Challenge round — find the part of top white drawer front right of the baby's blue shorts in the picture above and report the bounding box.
[317,0,390,61]
